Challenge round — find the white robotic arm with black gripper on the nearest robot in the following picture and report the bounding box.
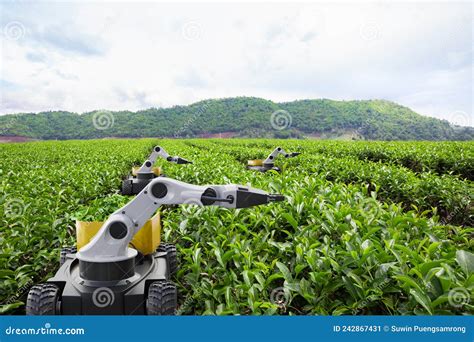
[77,177,284,262]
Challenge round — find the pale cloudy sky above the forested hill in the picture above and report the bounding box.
[0,1,474,126]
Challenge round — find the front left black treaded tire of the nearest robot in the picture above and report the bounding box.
[26,283,60,316]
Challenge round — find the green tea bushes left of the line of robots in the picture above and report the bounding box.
[0,140,156,312]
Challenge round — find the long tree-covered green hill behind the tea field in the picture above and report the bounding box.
[0,97,474,140]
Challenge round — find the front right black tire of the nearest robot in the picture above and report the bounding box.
[146,280,178,316]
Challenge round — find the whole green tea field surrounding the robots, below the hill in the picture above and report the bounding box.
[0,139,474,315]
